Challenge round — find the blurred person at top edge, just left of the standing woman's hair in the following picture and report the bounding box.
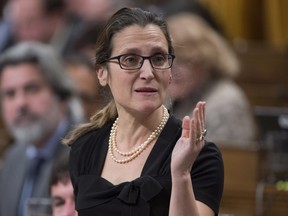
[63,0,135,58]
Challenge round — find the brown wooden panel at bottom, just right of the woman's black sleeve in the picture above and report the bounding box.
[220,147,260,216]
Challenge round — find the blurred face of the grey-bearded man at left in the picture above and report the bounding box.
[0,63,63,146]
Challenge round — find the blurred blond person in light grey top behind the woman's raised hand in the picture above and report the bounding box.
[168,12,257,148]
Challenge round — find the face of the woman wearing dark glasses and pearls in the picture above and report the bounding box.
[98,25,171,113]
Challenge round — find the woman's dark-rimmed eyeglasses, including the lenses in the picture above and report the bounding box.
[106,54,175,70]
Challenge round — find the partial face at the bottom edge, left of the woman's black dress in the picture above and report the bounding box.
[51,181,76,216]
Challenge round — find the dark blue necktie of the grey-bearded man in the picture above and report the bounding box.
[18,156,44,216]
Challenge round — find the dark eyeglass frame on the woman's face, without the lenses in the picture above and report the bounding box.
[104,53,175,70]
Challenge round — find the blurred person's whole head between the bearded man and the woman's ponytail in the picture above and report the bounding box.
[64,54,109,121]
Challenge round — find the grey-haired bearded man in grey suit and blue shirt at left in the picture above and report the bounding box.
[0,42,82,216]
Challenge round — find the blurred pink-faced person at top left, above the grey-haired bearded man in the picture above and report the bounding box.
[0,0,78,55]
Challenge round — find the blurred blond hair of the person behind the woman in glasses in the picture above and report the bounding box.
[167,12,239,78]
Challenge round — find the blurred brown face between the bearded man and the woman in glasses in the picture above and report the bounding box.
[67,65,103,119]
